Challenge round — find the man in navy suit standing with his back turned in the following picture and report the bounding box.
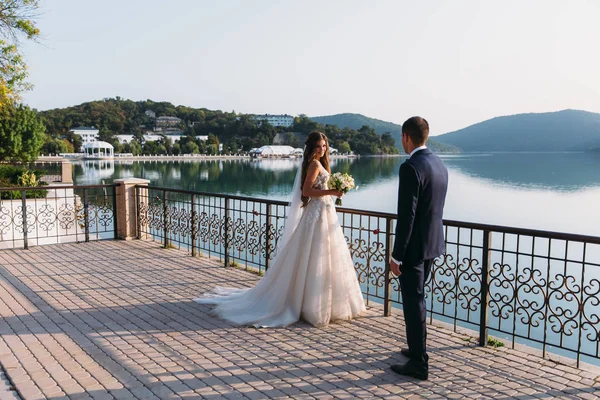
[390,117,448,380]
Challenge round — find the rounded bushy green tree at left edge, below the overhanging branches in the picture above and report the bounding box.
[0,104,45,161]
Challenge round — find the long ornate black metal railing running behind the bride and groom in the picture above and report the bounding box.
[136,186,600,365]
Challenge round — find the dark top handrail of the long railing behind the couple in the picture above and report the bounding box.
[136,184,600,244]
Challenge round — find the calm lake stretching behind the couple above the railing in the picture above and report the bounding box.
[65,152,600,236]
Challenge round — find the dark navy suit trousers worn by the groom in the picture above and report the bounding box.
[400,260,433,369]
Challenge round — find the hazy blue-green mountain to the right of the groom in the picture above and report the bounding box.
[435,110,600,151]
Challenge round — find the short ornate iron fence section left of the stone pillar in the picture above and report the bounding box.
[0,185,116,249]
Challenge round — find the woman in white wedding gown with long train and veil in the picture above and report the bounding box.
[194,131,366,327]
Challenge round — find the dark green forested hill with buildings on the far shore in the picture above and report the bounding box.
[34,97,398,155]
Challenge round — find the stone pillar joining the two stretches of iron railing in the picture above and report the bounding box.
[114,178,150,240]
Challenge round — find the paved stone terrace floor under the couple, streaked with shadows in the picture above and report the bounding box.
[0,241,600,399]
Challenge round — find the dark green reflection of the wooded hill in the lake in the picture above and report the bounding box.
[74,157,398,198]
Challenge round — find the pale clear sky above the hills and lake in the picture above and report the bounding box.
[18,0,600,135]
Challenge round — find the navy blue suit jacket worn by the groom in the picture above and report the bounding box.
[392,148,448,268]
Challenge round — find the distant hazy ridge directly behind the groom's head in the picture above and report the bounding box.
[310,113,460,153]
